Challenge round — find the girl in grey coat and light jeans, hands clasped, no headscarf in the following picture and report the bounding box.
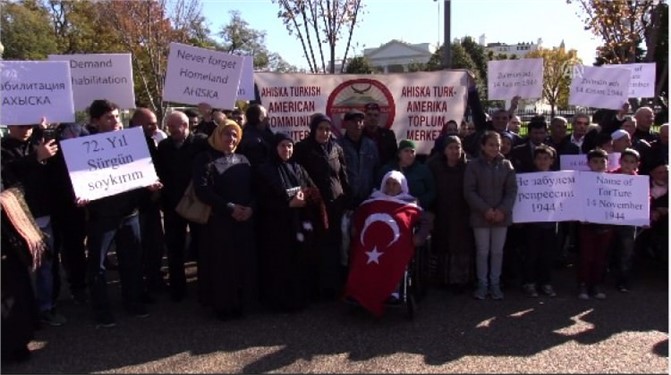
[464,131,517,300]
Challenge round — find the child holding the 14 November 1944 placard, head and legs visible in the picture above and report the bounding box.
[611,148,641,293]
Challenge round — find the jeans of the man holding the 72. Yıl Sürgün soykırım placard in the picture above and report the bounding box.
[87,215,143,314]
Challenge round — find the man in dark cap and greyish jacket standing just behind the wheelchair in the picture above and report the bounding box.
[338,109,380,208]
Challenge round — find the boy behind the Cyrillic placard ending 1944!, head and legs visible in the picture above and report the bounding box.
[522,144,557,297]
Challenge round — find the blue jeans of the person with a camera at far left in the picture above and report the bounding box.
[35,218,55,312]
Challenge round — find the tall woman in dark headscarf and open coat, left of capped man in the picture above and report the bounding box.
[294,114,350,299]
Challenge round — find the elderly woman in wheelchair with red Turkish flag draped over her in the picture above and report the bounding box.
[345,171,431,316]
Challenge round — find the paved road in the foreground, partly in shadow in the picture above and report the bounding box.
[2,260,669,373]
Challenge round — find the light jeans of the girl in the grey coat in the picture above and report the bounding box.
[473,227,508,286]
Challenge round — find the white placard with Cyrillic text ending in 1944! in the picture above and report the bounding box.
[513,171,582,223]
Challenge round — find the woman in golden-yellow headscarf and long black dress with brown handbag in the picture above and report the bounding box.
[193,120,256,320]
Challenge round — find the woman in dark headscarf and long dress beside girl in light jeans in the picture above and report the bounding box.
[427,135,475,292]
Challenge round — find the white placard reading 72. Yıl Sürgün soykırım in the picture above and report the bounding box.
[61,126,158,200]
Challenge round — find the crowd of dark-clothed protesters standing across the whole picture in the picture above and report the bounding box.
[0,75,669,366]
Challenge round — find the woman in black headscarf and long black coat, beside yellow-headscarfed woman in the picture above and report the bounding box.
[256,133,326,311]
